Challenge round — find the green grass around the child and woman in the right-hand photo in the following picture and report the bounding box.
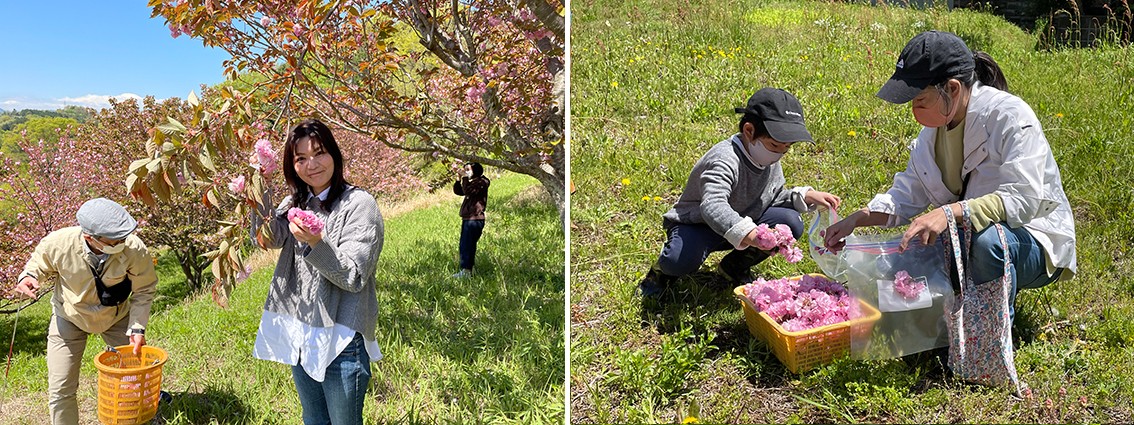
[570,0,1134,423]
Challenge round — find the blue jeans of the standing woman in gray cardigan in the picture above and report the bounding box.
[291,333,370,425]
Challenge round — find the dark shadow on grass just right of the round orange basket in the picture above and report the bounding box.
[153,385,269,424]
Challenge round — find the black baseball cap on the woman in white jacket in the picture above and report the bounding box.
[875,31,976,104]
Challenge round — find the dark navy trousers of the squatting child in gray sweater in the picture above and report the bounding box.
[658,206,803,277]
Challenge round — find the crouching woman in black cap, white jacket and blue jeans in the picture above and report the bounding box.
[824,31,1076,320]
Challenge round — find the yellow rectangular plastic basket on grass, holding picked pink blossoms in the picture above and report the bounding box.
[733,273,882,373]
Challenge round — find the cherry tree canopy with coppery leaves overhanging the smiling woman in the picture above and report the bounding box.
[150,0,565,213]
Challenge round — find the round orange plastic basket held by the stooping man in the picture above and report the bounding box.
[94,346,169,425]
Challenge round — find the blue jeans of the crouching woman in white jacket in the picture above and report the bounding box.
[954,223,1063,320]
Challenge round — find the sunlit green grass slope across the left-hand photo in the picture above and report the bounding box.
[0,173,565,424]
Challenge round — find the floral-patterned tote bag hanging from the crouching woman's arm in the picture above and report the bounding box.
[942,202,1026,396]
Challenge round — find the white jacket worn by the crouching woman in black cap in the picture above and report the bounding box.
[868,83,1077,280]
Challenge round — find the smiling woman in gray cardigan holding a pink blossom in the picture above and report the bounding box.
[253,119,383,425]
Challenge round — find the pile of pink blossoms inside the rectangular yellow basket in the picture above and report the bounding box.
[744,275,862,332]
